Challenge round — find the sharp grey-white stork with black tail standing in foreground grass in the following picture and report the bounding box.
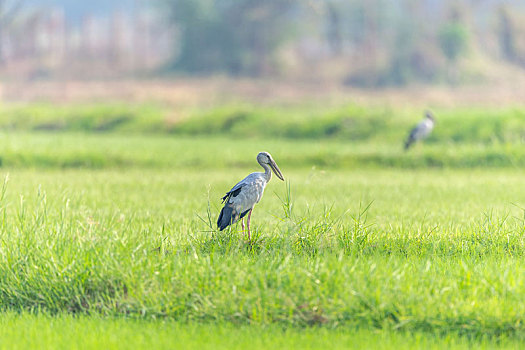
[217,152,284,240]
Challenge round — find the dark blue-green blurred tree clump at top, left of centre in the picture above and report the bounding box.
[160,0,297,75]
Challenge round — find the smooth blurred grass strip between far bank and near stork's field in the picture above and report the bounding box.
[0,132,525,170]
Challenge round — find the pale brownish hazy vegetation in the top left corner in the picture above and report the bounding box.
[0,0,173,81]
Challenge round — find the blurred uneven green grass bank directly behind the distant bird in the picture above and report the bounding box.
[0,101,525,145]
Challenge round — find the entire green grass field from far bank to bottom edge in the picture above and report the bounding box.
[0,102,525,349]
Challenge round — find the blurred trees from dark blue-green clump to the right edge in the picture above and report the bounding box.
[158,0,525,87]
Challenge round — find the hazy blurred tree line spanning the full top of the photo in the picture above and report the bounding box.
[0,0,525,95]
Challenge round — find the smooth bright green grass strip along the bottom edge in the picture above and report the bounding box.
[0,313,521,350]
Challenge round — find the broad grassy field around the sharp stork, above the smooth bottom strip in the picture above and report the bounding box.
[0,165,525,337]
